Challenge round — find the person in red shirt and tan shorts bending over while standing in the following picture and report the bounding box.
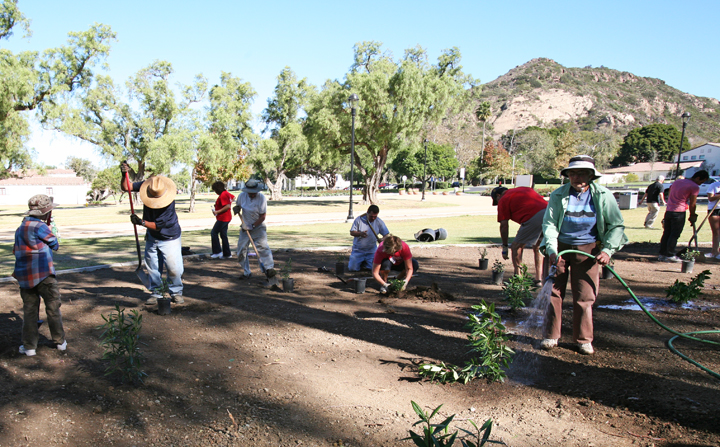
[490,186,547,285]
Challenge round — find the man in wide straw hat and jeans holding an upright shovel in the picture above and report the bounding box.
[120,162,185,305]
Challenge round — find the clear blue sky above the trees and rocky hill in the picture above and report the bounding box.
[7,0,720,170]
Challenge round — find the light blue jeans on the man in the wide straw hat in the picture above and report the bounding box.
[145,232,184,297]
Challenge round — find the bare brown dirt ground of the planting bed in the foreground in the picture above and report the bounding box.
[0,244,720,447]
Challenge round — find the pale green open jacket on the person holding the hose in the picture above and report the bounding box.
[541,182,628,256]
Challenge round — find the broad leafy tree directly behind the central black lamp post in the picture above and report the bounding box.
[306,41,471,203]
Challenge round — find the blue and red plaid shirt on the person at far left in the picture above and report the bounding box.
[13,216,59,289]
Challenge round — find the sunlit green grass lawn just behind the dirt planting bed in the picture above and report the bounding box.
[0,207,711,277]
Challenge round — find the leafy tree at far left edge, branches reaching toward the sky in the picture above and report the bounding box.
[0,0,115,176]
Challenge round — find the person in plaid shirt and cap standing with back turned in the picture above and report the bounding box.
[13,194,67,356]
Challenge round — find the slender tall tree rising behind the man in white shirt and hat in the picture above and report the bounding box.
[250,67,314,200]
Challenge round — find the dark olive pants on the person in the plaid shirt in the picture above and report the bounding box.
[20,276,65,349]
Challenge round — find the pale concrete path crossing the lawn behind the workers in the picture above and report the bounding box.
[0,193,497,243]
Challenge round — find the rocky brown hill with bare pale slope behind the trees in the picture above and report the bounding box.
[480,58,720,146]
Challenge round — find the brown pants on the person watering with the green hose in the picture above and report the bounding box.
[544,242,602,343]
